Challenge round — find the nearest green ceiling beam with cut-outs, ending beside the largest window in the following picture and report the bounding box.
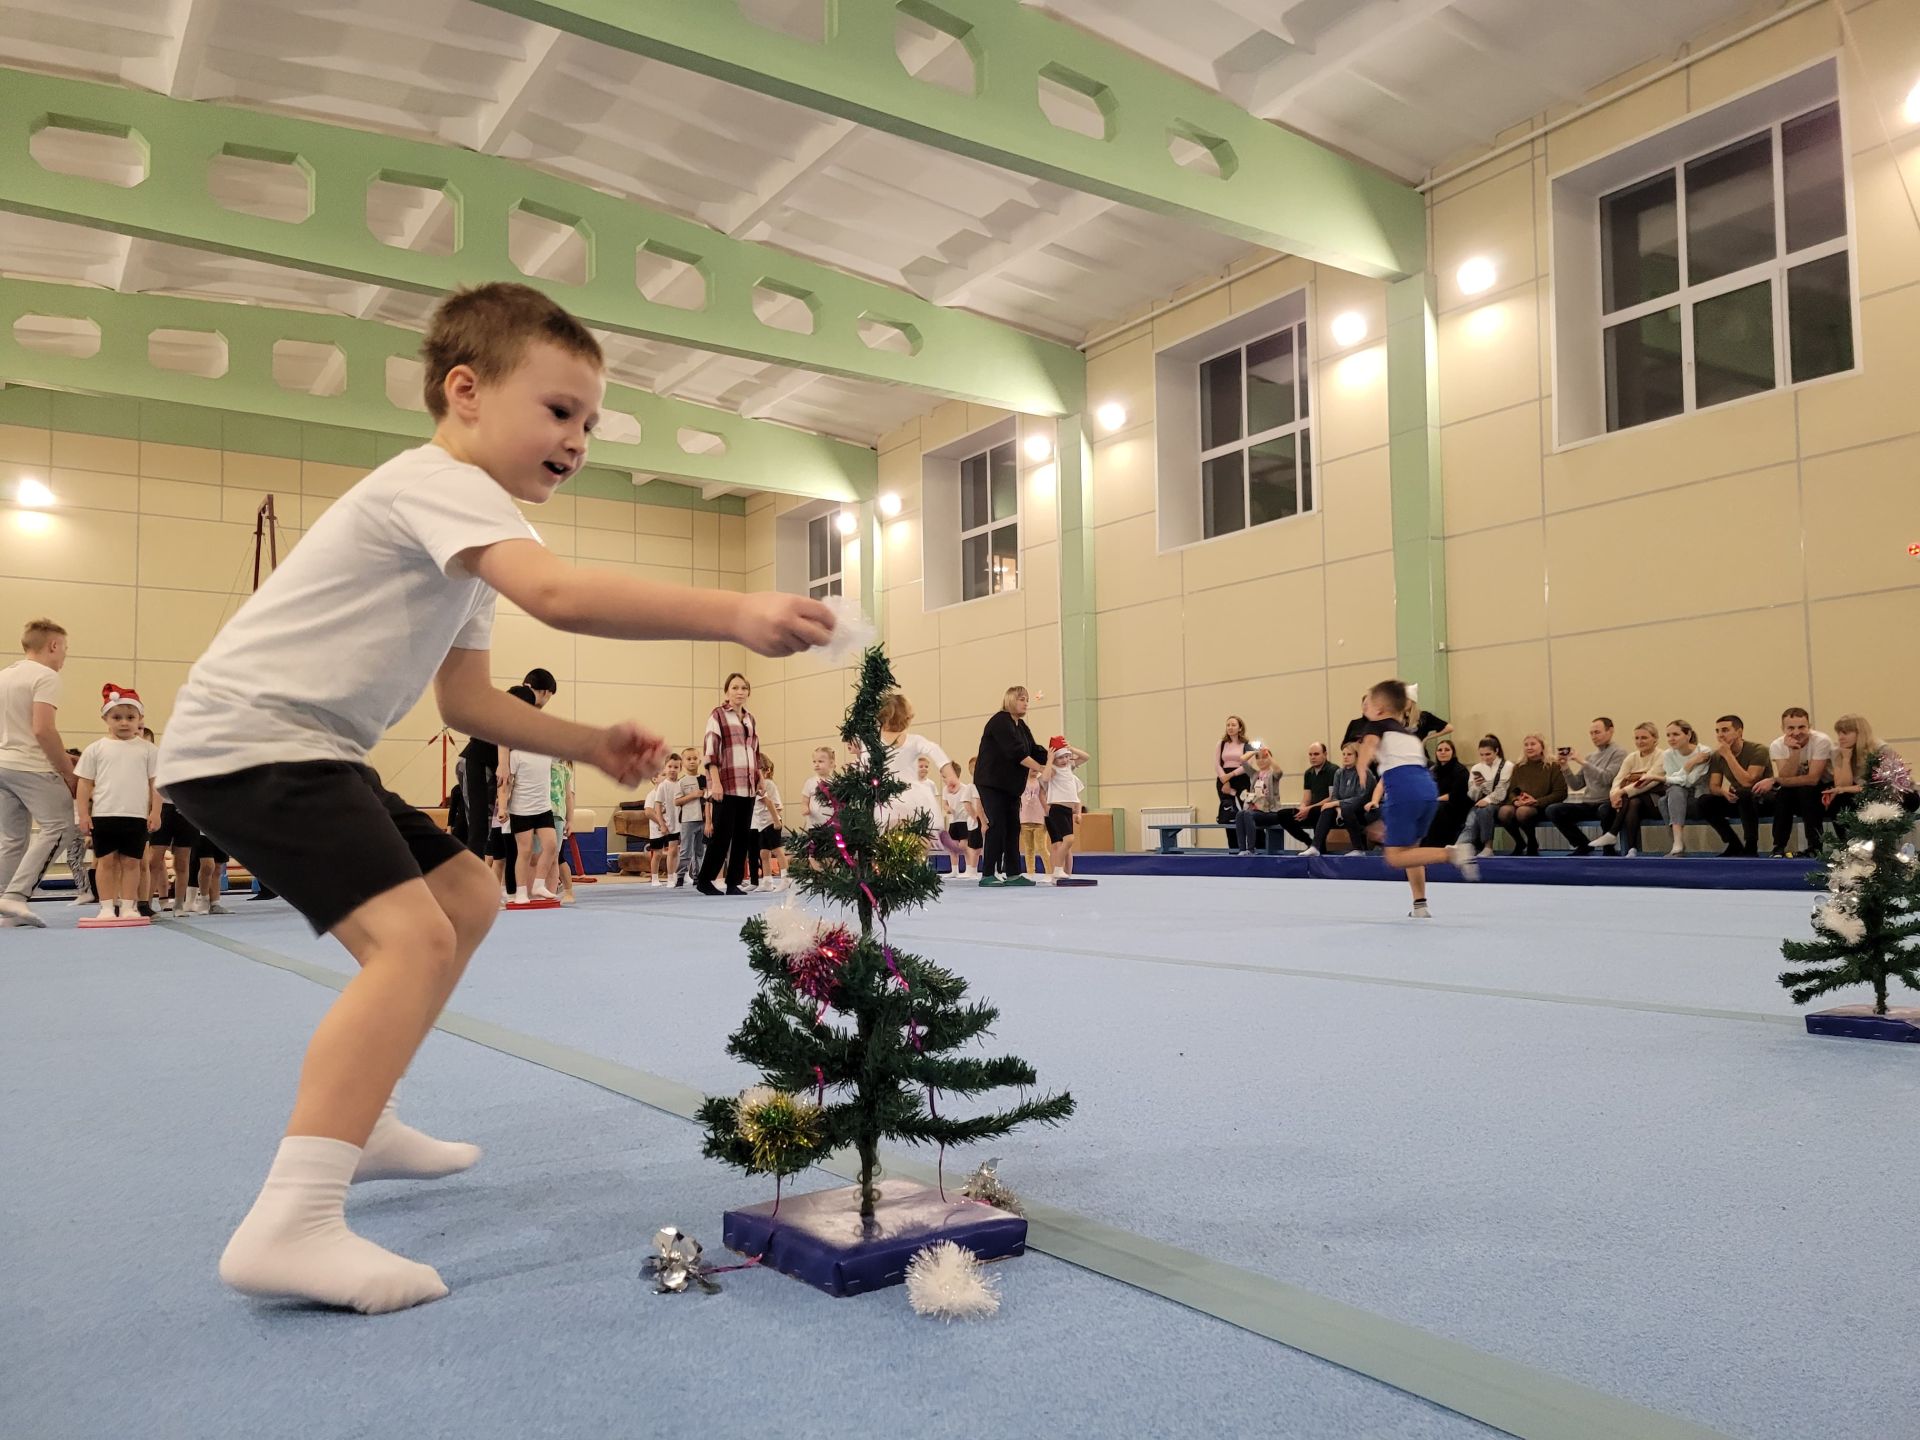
[464,0,1427,278]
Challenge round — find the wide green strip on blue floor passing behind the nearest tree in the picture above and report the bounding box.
[169,922,1728,1440]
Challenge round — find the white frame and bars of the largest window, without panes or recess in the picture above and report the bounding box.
[1594,100,1860,434]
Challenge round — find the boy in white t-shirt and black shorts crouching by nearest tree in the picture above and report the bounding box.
[159,284,833,1313]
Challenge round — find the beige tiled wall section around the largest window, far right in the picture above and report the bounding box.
[1430,0,1920,768]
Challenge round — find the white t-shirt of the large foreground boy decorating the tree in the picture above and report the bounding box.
[159,445,547,791]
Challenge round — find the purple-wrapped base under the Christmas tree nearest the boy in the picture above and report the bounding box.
[722,1181,1027,1296]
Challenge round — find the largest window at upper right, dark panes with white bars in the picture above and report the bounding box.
[1599,102,1853,430]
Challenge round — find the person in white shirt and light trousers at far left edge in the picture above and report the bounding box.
[0,620,79,929]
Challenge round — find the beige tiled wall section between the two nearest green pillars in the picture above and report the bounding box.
[1087,259,1394,829]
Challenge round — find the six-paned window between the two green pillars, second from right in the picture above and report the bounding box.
[1200,321,1313,540]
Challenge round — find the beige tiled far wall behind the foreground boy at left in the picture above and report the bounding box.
[0,426,745,806]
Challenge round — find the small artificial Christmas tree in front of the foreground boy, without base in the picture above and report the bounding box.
[699,645,1073,1219]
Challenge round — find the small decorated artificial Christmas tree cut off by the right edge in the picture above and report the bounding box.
[1780,751,1920,1029]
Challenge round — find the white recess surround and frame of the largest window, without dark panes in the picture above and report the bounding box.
[1548,52,1866,453]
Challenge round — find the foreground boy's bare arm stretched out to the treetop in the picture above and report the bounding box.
[461,540,833,657]
